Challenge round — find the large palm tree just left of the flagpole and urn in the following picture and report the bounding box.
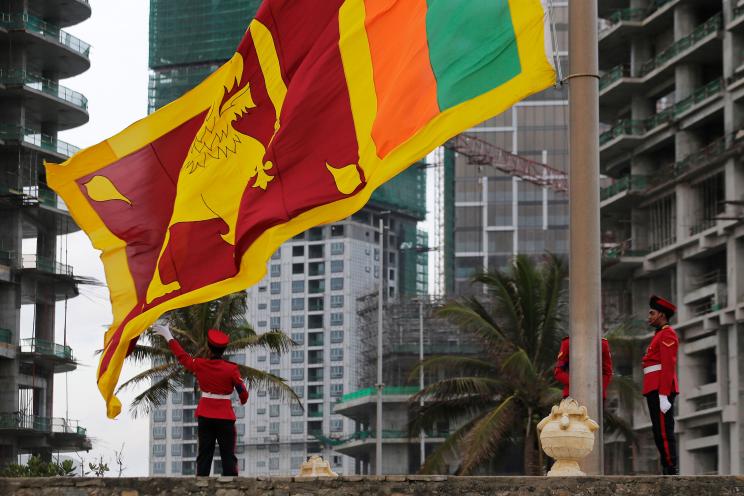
[409,254,567,475]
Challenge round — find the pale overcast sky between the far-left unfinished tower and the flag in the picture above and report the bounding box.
[45,0,149,476]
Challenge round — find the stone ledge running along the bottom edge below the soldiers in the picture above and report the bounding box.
[0,475,744,496]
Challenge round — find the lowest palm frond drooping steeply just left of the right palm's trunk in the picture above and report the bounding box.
[458,396,518,475]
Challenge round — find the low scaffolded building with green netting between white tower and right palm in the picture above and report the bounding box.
[326,294,481,475]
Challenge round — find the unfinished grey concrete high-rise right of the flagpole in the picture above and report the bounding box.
[599,0,744,474]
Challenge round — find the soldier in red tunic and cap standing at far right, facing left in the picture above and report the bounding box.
[642,296,679,475]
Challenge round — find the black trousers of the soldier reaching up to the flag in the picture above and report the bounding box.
[196,417,238,476]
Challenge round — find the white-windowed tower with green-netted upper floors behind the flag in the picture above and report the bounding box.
[145,0,428,475]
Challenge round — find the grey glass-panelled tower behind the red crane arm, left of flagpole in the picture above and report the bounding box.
[442,2,568,294]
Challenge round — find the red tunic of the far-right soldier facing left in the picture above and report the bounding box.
[642,325,679,396]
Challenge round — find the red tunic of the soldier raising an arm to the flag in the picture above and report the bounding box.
[168,339,248,420]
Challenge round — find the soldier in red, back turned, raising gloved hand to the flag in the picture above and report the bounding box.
[153,325,248,476]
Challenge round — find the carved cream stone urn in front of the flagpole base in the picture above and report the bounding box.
[537,397,599,477]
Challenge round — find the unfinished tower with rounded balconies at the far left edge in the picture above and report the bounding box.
[0,0,91,466]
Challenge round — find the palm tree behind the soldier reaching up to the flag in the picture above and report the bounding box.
[117,292,299,418]
